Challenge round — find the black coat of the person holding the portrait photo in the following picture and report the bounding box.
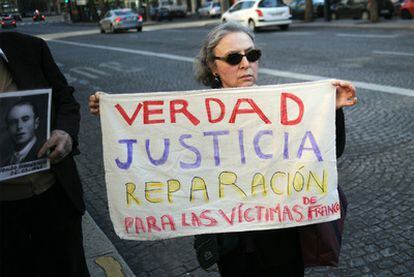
[0,32,85,213]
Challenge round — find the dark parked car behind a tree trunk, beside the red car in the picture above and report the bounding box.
[331,0,394,20]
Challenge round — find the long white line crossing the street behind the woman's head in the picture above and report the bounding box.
[52,40,414,97]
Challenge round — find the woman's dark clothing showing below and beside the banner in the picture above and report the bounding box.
[194,109,345,270]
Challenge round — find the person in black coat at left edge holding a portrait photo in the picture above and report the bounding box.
[0,32,89,277]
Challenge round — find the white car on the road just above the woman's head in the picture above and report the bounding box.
[221,0,292,31]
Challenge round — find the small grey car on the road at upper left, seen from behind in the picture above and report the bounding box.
[99,9,142,33]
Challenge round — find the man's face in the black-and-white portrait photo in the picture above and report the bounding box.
[7,103,39,150]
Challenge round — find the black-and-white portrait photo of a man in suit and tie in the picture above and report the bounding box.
[0,89,51,181]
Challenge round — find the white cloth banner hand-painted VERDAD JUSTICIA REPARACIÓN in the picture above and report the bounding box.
[100,80,340,240]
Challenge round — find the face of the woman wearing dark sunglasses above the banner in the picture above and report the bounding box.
[212,32,259,88]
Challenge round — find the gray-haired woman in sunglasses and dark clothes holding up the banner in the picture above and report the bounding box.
[89,23,356,276]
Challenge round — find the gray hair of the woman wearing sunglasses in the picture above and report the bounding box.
[194,22,254,88]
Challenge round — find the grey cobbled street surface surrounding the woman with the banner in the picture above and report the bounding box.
[4,18,414,277]
